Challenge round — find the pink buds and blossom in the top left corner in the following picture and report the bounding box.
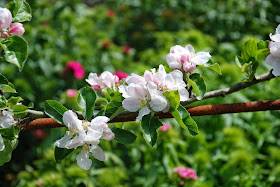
[0,7,25,37]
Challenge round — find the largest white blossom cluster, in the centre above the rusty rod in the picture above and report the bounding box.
[119,65,189,122]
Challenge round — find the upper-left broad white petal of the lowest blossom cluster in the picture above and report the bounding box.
[62,110,83,130]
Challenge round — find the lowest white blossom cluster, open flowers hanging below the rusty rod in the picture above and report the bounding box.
[54,110,115,170]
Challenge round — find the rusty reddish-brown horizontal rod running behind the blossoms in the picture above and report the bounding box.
[21,99,280,130]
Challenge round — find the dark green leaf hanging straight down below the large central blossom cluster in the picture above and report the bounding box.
[141,114,163,146]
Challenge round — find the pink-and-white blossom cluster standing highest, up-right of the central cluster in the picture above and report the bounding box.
[166,45,211,72]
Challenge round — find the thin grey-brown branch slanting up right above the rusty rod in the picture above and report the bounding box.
[181,71,275,106]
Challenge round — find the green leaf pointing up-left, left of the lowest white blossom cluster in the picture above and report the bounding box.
[44,100,68,124]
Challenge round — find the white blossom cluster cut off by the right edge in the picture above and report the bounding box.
[265,25,280,76]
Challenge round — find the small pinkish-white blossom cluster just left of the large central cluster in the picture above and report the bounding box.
[86,71,119,91]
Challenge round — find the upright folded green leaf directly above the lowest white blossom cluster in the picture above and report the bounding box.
[77,86,96,120]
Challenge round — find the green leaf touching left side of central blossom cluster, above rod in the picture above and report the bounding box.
[105,96,124,120]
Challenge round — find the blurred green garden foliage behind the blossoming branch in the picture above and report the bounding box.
[0,0,280,187]
